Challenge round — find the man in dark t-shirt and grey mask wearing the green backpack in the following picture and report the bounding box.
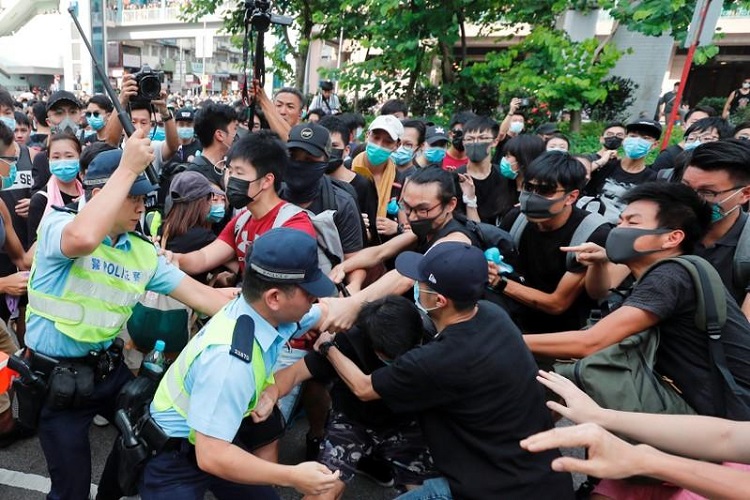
[524,182,750,417]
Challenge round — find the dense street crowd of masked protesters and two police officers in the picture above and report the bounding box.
[0,75,750,500]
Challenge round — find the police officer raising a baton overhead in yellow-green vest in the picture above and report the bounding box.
[25,132,235,500]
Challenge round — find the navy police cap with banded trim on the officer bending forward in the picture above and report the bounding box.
[246,227,334,297]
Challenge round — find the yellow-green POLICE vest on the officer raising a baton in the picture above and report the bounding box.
[27,236,158,343]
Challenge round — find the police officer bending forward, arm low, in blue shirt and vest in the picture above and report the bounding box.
[139,228,339,500]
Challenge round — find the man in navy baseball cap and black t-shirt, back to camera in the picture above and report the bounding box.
[317,241,573,499]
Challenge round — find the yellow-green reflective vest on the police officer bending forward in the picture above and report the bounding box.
[154,309,274,443]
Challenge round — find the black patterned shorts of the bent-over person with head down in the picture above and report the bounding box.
[318,410,440,484]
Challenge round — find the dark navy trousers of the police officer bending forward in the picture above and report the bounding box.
[138,441,279,500]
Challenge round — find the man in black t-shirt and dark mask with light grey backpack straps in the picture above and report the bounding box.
[500,151,609,333]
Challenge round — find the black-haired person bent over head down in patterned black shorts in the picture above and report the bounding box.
[266,296,435,497]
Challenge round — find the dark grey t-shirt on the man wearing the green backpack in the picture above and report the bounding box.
[623,262,750,415]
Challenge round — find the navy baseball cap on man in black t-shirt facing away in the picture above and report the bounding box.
[396,241,488,302]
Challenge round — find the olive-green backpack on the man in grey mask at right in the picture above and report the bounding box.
[554,255,750,420]
